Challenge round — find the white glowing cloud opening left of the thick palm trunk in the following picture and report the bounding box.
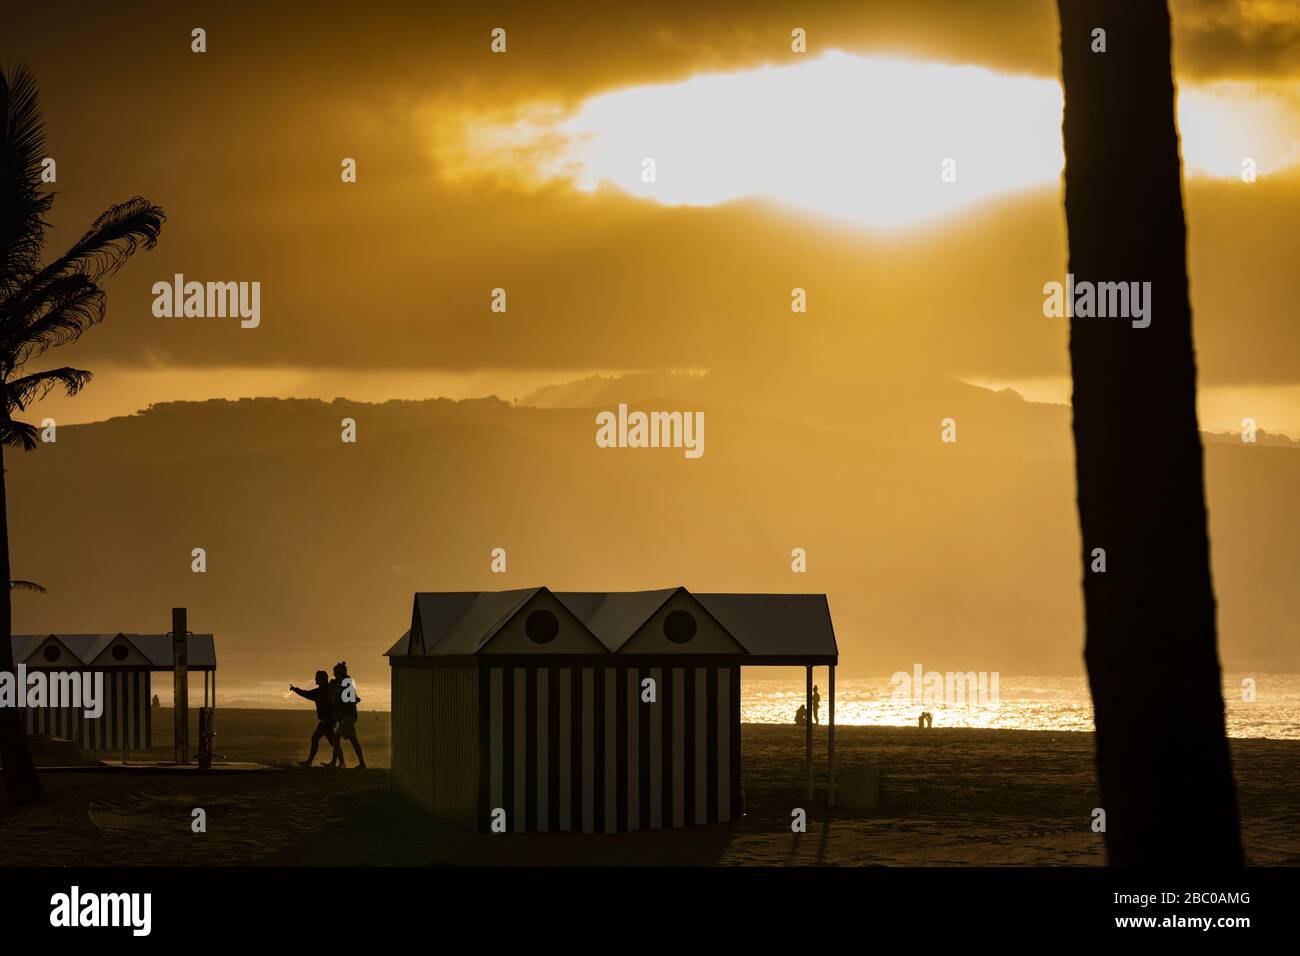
[560,52,1062,226]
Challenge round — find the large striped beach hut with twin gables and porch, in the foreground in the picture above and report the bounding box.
[386,588,839,832]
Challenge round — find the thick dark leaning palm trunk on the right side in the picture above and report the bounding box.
[1058,0,1242,865]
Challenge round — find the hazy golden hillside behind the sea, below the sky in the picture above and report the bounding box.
[8,384,1300,697]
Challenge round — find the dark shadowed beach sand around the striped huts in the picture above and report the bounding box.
[0,710,1300,866]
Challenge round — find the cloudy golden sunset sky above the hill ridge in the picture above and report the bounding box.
[0,0,1300,436]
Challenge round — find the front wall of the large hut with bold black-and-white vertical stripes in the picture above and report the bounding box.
[480,663,740,834]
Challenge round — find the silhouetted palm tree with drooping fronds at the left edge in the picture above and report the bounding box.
[0,61,164,805]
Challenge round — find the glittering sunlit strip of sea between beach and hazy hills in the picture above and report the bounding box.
[208,669,1300,740]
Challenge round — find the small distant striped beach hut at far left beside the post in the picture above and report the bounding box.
[13,633,217,750]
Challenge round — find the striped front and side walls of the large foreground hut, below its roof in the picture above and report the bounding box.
[393,663,740,832]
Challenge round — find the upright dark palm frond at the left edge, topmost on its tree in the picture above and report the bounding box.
[0,66,53,293]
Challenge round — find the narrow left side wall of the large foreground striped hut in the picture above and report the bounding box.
[393,663,478,830]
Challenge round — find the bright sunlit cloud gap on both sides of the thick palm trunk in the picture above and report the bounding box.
[445,51,1300,229]
